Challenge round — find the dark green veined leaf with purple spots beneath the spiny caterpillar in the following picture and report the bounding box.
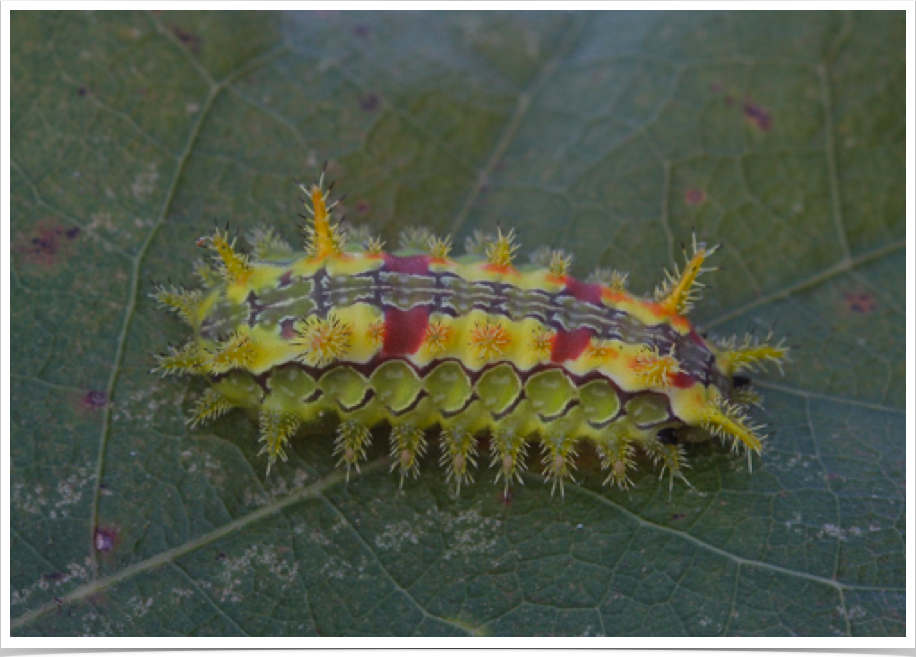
[9,12,907,636]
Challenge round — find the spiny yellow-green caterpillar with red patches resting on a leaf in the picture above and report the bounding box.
[151,171,789,494]
